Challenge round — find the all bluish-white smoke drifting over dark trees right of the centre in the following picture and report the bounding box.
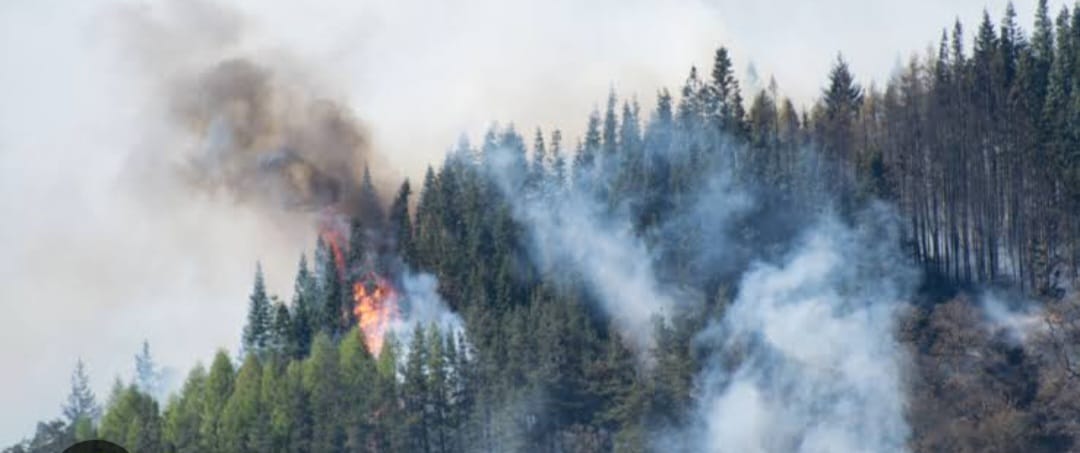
[482,120,920,453]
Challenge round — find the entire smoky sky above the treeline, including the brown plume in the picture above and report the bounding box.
[0,0,1058,444]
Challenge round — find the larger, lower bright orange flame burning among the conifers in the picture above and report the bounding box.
[352,276,397,356]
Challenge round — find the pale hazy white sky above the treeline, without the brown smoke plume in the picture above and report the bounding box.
[0,0,1061,445]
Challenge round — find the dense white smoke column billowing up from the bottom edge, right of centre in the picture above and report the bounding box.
[678,209,917,453]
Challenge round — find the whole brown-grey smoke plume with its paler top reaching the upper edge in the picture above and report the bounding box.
[117,2,392,214]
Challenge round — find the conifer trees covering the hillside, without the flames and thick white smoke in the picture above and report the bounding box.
[19,5,1080,453]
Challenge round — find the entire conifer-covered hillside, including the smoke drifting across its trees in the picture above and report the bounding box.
[5,0,1080,453]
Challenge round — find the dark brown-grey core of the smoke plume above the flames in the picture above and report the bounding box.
[172,58,373,210]
